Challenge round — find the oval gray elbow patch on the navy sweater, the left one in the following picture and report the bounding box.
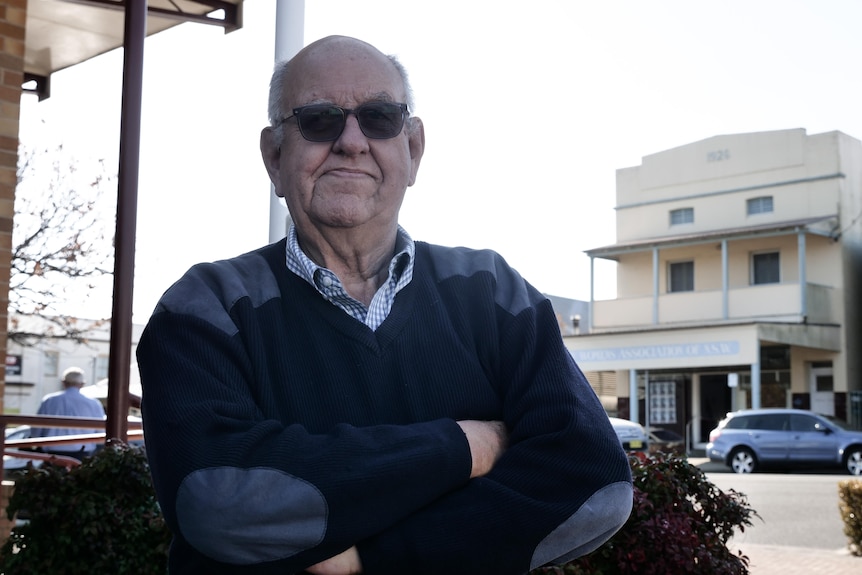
[177,467,327,565]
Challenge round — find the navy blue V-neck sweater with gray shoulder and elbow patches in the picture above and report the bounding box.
[137,237,632,575]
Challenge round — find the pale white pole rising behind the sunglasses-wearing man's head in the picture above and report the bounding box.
[269,0,305,242]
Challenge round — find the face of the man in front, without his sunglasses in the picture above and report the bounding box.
[261,40,424,234]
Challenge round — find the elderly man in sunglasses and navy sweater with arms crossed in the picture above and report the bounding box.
[138,37,632,575]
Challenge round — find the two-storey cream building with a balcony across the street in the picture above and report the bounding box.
[565,129,862,447]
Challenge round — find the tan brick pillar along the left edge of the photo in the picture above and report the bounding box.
[0,0,27,544]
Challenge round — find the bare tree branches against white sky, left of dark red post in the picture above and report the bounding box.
[8,146,116,345]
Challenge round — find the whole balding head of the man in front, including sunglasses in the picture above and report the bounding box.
[260,36,425,245]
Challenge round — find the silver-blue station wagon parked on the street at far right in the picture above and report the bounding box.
[706,409,862,475]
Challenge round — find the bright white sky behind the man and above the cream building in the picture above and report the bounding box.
[16,0,862,323]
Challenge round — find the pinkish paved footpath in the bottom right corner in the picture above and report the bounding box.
[689,457,862,575]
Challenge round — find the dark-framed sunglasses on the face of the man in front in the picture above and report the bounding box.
[281,102,407,142]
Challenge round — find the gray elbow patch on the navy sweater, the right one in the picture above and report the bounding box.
[530,482,633,569]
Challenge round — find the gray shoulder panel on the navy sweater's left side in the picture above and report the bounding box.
[153,248,280,335]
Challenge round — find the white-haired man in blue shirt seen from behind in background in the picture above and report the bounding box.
[33,367,105,459]
